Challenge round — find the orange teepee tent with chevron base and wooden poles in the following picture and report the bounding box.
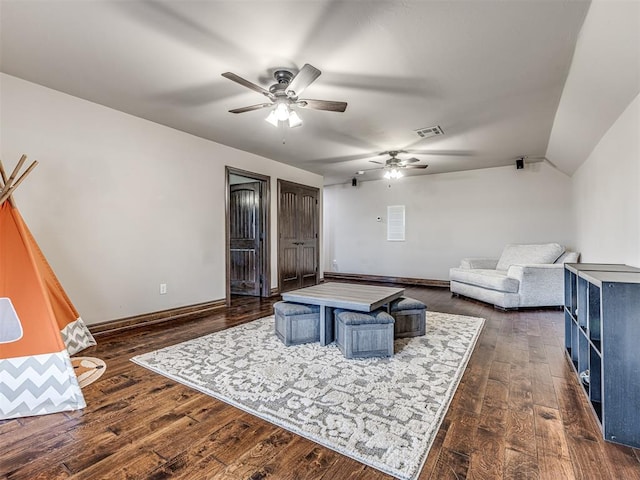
[0,156,95,419]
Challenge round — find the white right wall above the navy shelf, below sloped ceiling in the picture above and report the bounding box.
[573,96,640,267]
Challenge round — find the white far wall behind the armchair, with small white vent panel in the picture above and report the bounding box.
[324,163,574,280]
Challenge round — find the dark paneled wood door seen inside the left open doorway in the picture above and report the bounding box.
[229,182,262,296]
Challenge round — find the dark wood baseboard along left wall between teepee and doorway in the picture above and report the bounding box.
[88,300,226,337]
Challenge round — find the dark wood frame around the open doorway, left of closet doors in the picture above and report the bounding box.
[224,165,271,306]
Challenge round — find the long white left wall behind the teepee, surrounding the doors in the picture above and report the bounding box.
[0,74,322,323]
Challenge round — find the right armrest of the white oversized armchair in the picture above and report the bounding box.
[507,264,564,306]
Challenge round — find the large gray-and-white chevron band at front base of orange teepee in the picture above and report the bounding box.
[0,350,86,420]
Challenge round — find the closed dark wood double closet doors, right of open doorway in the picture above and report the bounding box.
[278,180,319,292]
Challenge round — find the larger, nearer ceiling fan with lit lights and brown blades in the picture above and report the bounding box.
[222,63,347,128]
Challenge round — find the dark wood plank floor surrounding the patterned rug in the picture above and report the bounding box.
[0,287,640,480]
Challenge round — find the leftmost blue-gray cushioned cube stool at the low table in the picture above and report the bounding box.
[273,302,320,347]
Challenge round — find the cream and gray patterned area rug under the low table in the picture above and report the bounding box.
[132,312,484,480]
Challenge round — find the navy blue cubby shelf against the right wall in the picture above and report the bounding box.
[564,263,640,448]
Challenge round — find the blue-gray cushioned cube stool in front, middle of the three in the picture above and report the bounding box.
[334,309,394,358]
